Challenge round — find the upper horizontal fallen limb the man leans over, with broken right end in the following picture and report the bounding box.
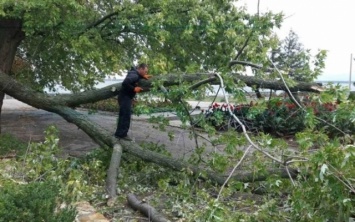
[0,72,322,111]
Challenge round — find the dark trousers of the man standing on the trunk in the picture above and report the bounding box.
[115,94,132,137]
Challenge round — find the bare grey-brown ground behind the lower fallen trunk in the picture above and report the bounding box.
[1,99,215,157]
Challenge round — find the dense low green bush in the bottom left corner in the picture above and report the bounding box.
[0,182,76,222]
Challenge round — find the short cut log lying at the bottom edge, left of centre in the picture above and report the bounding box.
[127,194,169,222]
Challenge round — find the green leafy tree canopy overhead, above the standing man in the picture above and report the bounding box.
[0,0,282,90]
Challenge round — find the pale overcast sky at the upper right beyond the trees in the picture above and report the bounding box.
[237,0,355,82]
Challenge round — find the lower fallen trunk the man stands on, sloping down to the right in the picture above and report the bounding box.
[0,71,297,184]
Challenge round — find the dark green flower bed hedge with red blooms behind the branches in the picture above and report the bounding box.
[200,98,355,137]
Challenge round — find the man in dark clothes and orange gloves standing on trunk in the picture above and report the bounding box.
[115,63,151,141]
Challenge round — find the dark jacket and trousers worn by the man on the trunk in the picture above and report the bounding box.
[115,67,142,138]
